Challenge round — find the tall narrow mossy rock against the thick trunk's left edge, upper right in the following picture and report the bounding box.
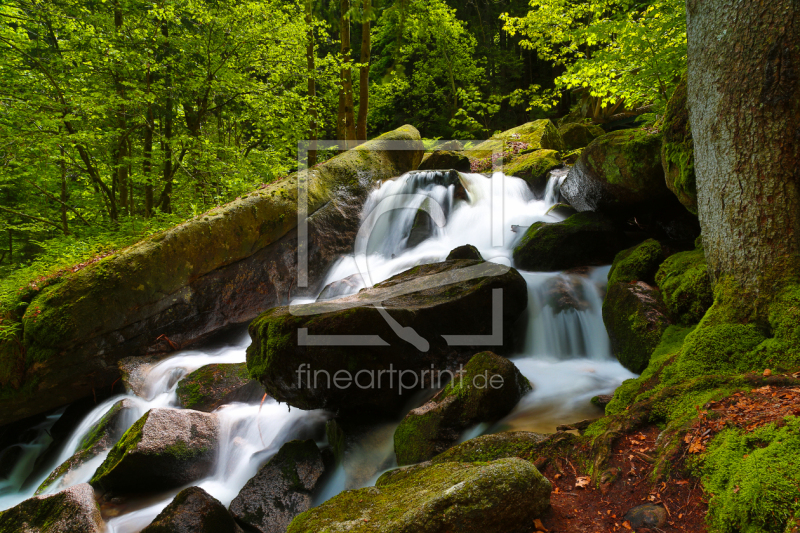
[661,74,697,215]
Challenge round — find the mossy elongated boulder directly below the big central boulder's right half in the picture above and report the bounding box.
[394,352,531,466]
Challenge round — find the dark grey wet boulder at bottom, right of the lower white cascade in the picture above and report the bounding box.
[230,440,325,533]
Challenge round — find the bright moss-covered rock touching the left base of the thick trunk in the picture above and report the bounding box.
[656,248,714,325]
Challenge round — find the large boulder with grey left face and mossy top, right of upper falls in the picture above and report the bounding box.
[561,130,672,213]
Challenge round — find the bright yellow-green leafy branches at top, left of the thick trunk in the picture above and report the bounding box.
[503,0,686,108]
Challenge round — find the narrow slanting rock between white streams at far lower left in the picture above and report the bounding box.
[36,400,135,494]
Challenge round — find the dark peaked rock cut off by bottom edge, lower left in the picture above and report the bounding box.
[141,487,242,533]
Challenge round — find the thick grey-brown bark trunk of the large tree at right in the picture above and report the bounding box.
[687,0,800,296]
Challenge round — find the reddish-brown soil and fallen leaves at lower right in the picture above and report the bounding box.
[534,382,800,533]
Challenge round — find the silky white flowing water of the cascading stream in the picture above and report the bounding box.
[0,171,634,533]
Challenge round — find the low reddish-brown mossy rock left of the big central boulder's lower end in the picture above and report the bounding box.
[176,363,264,413]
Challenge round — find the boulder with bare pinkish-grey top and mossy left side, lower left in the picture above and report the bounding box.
[90,409,219,492]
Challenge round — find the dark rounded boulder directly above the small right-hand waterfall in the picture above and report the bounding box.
[514,212,627,271]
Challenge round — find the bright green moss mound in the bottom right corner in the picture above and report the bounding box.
[696,416,800,533]
